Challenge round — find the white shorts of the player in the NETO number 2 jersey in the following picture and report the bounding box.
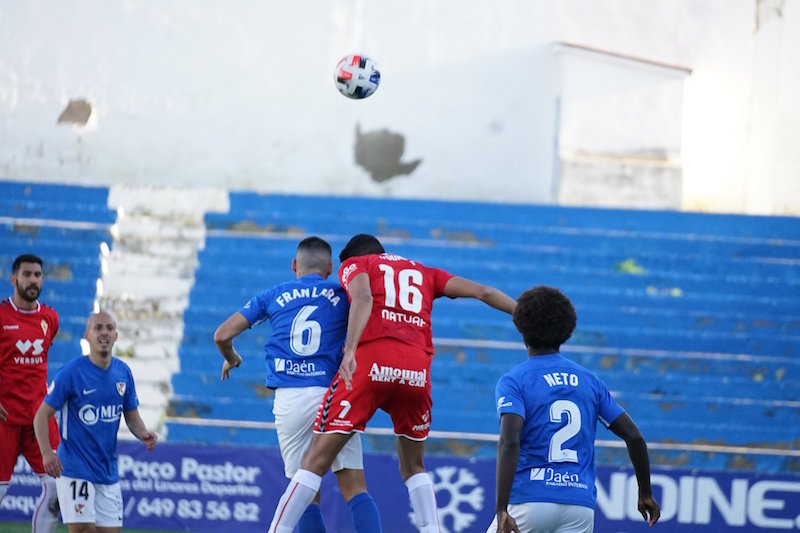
[486,502,594,533]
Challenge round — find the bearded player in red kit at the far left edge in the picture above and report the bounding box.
[0,254,59,533]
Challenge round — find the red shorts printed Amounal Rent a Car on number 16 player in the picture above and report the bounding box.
[314,339,433,440]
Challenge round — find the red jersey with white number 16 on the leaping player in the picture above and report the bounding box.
[339,253,453,354]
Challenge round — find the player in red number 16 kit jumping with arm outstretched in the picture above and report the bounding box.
[269,234,516,533]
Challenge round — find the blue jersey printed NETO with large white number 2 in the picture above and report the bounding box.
[495,354,624,508]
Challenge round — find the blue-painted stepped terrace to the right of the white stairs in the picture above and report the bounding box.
[170,193,800,470]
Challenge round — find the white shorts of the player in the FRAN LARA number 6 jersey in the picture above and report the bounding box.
[272,387,364,479]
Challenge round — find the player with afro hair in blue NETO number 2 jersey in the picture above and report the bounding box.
[487,286,661,533]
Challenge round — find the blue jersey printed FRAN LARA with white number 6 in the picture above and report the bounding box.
[239,274,350,388]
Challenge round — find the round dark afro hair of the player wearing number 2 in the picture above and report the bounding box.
[513,285,578,351]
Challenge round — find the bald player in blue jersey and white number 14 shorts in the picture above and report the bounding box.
[33,312,157,533]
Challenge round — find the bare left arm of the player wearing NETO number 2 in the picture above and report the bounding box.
[495,413,525,533]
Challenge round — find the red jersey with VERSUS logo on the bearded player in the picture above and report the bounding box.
[0,298,58,425]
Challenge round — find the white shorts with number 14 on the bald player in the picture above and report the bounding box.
[56,476,122,527]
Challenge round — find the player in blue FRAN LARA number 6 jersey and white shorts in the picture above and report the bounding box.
[214,237,381,533]
